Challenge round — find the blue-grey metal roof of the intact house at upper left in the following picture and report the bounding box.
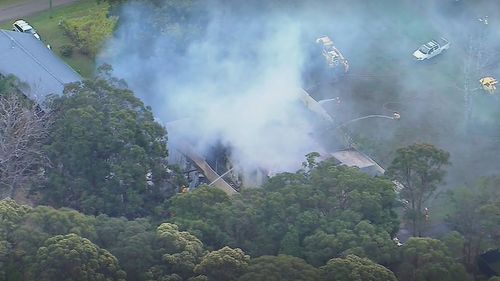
[0,29,82,102]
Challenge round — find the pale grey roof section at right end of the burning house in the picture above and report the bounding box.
[331,149,385,176]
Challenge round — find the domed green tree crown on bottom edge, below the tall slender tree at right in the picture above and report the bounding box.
[396,238,472,281]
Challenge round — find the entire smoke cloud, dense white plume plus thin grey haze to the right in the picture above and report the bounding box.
[102,0,500,188]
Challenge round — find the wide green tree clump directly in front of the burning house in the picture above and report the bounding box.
[170,160,399,265]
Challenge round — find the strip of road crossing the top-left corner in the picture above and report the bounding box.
[0,0,78,23]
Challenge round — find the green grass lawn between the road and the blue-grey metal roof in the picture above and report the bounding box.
[0,0,108,78]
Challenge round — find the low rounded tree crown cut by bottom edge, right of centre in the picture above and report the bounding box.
[321,255,397,281]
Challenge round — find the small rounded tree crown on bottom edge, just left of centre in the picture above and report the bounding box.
[194,246,250,281]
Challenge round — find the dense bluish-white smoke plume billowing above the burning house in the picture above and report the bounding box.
[102,0,328,171]
